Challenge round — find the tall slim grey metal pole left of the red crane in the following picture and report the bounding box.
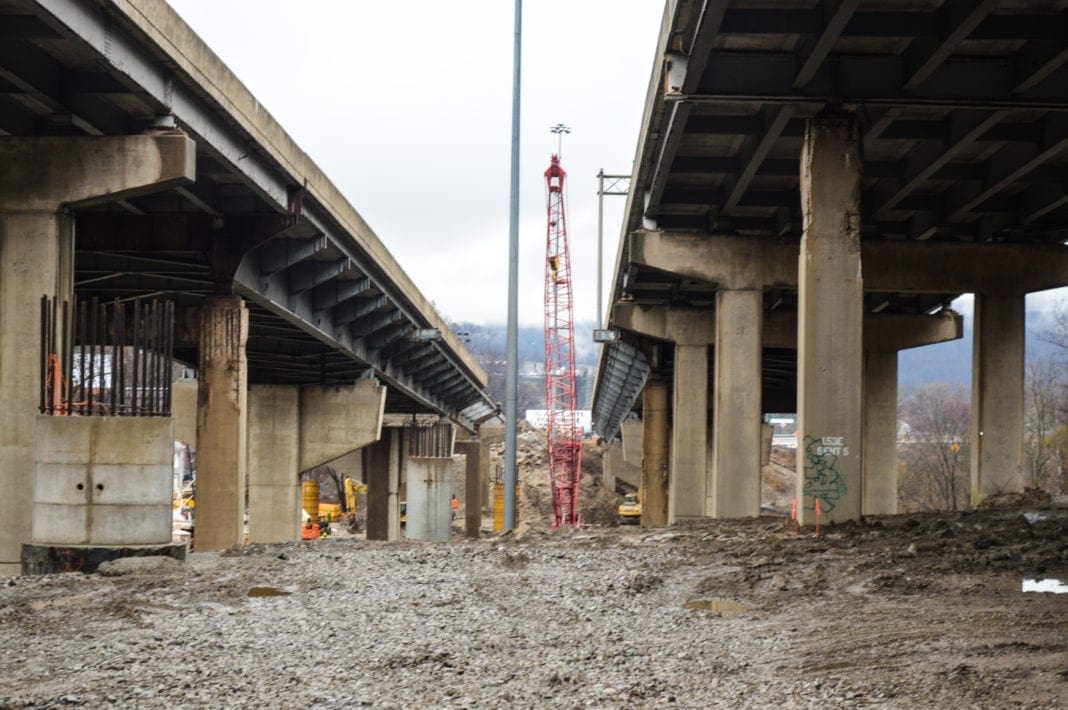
[504,0,523,530]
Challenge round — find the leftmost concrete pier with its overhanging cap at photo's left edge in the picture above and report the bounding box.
[0,132,195,574]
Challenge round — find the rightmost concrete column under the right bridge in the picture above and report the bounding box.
[972,294,1024,505]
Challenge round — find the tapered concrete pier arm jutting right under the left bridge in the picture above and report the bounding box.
[299,380,386,471]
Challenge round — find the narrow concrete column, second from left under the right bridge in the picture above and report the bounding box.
[666,345,709,524]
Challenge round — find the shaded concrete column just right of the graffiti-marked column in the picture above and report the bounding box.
[861,352,897,516]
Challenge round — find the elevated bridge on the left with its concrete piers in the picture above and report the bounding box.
[0,0,498,573]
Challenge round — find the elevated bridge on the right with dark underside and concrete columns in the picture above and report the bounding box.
[594,0,1068,524]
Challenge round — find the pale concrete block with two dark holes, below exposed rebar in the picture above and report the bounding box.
[31,414,174,547]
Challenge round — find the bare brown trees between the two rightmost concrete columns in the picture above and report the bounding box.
[898,382,971,511]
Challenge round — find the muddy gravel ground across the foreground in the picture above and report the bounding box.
[0,495,1068,708]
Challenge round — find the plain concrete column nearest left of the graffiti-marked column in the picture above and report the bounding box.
[713,288,764,518]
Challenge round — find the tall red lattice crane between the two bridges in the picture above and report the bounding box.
[545,155,582,530]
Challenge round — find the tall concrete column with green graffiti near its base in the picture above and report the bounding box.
[797,114,864,523]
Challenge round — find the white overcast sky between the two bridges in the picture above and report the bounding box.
[163,0,663,325]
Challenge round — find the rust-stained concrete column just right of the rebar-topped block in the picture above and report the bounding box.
[193,296,247,552]
